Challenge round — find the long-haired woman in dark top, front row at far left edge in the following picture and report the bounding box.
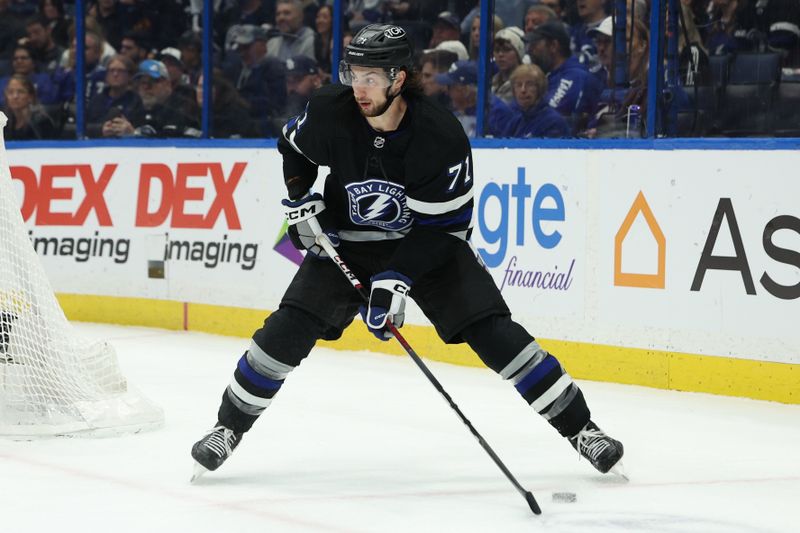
[3,74,55,141]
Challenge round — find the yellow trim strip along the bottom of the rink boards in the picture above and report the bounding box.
[57,294,800,404]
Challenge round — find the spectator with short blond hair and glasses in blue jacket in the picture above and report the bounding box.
[497,65,570,138]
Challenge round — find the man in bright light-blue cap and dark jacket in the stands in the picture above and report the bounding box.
[108,59,200,137]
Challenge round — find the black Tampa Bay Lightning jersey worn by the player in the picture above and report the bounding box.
[278,85,473,280]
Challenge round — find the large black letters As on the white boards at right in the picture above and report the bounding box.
[692,198,800,300]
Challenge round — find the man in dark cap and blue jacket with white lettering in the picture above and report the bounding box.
[526,22,602,117]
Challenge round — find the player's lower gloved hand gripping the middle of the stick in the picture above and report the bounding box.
[360,270,411,341]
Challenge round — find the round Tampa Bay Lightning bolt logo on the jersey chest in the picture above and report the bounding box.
[345,179,411,231]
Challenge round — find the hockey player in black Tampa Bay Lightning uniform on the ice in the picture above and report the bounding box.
[192,24,623,479]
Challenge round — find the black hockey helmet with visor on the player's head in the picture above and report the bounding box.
[339,24,414,85]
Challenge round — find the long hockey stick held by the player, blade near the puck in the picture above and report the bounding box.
[308,223,542,515]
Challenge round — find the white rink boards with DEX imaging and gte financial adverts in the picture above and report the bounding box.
[8,147,800,362]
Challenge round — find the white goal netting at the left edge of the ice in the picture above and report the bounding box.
[0,113,164,436]
